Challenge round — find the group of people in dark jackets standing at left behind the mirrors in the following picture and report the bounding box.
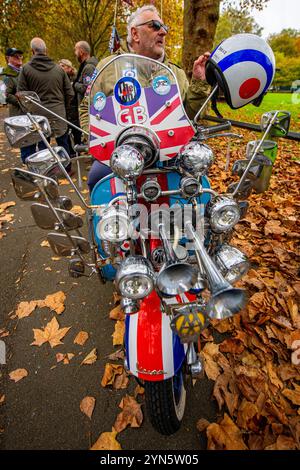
[0,38,98,163]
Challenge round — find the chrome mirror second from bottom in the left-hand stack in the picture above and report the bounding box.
[31,203,83,230]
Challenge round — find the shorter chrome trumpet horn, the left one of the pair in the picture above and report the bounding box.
[156,222,198,297]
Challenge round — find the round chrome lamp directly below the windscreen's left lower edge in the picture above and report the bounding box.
[110,145,144,180]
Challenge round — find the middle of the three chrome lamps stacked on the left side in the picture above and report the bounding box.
[97,206,129,243]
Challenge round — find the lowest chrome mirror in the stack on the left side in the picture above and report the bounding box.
[47,233,90,256]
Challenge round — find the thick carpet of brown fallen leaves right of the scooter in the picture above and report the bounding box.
[198,130,300,450]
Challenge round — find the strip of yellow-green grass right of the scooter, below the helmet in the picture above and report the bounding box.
[218,93,300,132]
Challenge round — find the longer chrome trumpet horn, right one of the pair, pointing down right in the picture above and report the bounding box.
[186,221,247,320]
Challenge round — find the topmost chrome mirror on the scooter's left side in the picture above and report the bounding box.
[4,116,51,148]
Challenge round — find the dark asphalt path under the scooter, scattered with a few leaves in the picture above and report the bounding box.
[0,104,218,450]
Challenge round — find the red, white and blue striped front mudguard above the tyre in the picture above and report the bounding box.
[125,291,195,382]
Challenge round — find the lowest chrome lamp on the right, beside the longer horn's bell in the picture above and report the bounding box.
[215,245,250,284]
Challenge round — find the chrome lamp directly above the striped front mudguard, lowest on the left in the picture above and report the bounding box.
[116,256,154,300]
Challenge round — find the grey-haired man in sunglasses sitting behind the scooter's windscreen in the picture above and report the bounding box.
[80,5,210,191]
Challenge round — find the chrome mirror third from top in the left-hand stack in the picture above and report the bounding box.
[11,168,59,202]
